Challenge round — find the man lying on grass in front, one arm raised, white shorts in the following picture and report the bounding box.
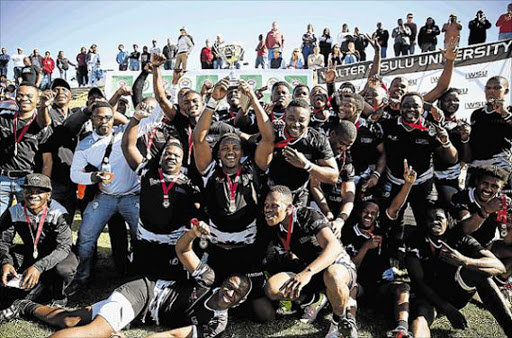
[0,222,251,338]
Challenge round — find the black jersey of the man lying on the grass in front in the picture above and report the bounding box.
[158,264,228,338]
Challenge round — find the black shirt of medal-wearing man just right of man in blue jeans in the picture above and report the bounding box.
[137,158,200,241]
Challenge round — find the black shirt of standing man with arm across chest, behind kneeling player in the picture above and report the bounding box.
[269,127,334,191]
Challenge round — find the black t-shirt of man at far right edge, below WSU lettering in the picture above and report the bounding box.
[469,106,512,162]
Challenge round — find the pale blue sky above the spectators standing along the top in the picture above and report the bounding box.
[0,0,510,75]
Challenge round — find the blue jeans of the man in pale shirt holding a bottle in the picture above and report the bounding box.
[76,193,139,284]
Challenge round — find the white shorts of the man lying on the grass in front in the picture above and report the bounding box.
[92,291,135,331]
